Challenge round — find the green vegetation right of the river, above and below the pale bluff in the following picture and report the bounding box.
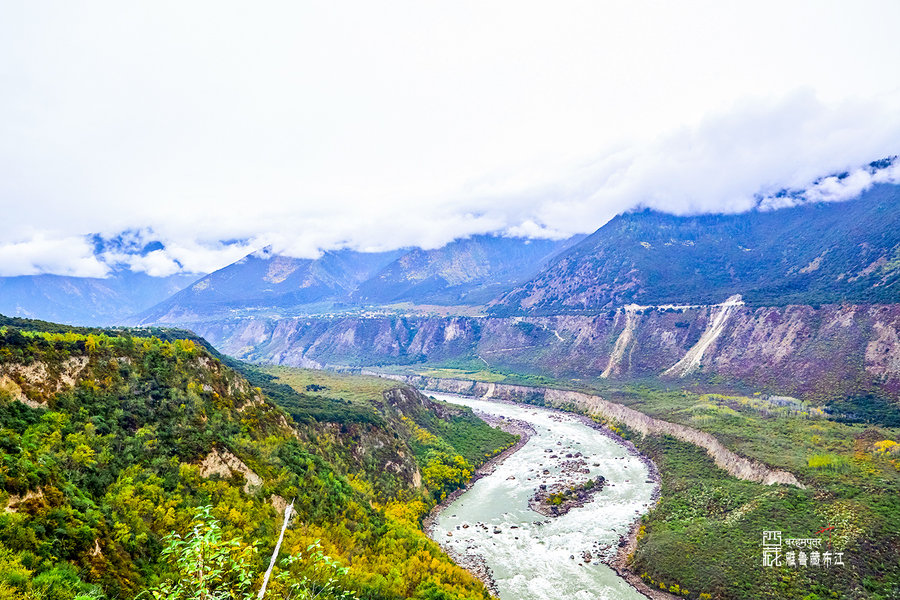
[400,364,900,600]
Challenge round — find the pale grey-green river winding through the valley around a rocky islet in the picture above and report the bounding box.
[431,394,654,600]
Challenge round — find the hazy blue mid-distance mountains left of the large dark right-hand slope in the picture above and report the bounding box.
[136,235,583,323]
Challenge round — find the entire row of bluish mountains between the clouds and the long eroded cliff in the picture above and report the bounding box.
[7,177,900,332]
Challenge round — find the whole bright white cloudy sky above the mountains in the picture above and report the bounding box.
[0,0,900,277]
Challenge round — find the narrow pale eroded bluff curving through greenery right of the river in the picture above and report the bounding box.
[397,376,804,487]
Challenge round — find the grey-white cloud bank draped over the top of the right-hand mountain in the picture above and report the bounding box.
[460,90,900,233]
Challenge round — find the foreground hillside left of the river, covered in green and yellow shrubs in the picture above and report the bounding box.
[0,318,513,600]
